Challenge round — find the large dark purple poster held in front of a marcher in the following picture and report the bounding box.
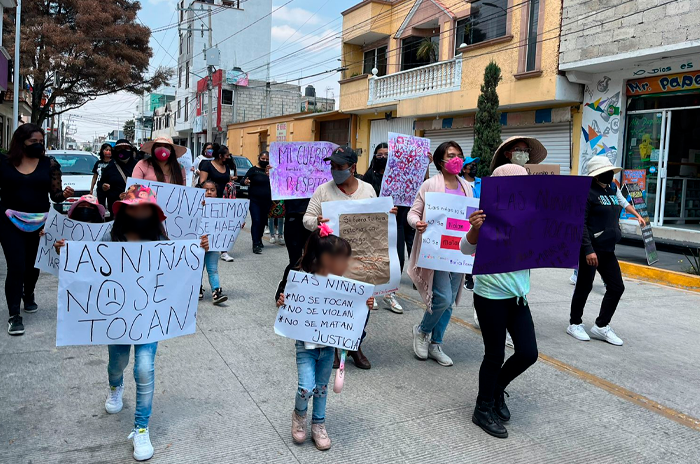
[472,176,591,274]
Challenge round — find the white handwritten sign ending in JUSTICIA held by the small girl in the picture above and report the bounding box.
[275,271,374,351]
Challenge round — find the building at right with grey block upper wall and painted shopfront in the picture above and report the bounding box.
[559,0,700,244]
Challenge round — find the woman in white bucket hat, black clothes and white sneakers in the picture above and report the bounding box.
[566,156,625,346]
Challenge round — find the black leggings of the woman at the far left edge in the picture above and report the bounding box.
[0,212,40,317]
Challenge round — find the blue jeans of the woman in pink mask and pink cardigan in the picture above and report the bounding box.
[420,271,462,344]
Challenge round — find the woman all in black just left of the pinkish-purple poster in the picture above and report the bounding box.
[243,151,272,255]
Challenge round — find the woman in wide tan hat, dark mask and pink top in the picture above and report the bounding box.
[132,135,187,185]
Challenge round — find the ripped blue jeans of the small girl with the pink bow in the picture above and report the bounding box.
[294,341,335,424]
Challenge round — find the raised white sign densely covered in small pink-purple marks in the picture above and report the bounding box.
[379,132,430,206]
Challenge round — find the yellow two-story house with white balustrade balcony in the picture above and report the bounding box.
[340,0,581,173]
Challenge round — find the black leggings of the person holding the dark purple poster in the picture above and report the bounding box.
[474,293,538,402]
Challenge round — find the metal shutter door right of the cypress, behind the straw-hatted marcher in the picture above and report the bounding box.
[501,122,571,176]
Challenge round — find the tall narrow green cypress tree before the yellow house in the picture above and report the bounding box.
[472,61,501,177]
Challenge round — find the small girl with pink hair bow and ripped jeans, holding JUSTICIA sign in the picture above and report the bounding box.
[277,224,374,451]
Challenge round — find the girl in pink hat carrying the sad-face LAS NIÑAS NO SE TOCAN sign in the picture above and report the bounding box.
[57,184,209,461]
